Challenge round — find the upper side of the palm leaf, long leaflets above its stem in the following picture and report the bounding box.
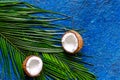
[0,2,68,52]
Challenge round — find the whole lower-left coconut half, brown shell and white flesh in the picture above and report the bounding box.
[23,56,43,77]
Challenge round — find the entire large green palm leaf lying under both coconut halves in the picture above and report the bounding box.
[0,1,96,80]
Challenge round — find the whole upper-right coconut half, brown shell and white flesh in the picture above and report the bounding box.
[61,30,83,54]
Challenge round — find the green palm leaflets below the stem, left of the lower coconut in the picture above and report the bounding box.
[0,37,25,79]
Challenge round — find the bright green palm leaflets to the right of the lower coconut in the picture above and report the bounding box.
[43,53,95,80]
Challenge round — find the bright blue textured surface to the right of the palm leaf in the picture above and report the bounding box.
[0,0,120,80]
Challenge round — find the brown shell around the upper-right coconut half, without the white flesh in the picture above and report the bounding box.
[62,30,83,54]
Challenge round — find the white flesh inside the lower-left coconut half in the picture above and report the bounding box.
[26,56,43,76]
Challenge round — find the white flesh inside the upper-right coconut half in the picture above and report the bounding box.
[62,32,78,53]
